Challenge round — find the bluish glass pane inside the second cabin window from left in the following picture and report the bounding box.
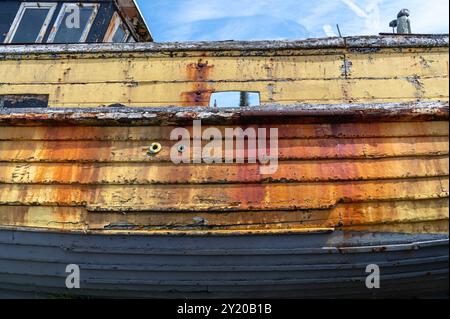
[53,5,94,43]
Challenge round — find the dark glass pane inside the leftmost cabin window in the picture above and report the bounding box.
[11,8,50,43]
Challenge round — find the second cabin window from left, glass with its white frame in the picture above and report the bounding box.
[47,3,98,43]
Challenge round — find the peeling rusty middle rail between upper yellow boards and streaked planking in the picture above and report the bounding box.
[0,101,449,125]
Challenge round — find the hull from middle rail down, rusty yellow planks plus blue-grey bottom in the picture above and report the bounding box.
[0,102,449,298]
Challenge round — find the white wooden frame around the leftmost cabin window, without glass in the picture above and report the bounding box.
[4,2,58,43]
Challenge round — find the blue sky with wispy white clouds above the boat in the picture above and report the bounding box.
[137,0,449,41]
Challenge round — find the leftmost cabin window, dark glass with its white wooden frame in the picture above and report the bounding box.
[5,2,57,43]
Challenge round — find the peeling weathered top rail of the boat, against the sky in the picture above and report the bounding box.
[0,34,449,58]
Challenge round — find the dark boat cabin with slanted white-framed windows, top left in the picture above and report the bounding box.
[0,0,152,44]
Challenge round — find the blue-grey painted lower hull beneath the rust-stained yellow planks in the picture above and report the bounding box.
[0,230,449,298]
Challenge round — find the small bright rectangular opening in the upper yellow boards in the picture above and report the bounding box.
[209,91,261,108]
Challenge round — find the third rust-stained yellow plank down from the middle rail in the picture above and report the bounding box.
[0,156,449,185]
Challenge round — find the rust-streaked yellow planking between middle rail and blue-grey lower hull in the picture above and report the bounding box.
[0,117,449,233]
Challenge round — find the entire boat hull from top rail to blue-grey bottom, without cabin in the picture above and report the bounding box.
[0,35,449,298]
